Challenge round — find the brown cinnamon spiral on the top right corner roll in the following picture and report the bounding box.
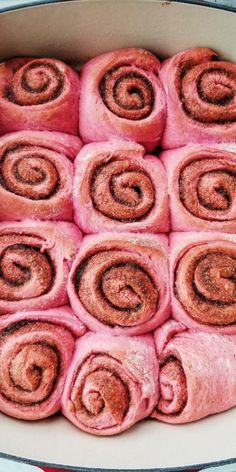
[179,56,236,125]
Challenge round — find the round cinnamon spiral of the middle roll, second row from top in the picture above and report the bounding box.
[90,159,155,222]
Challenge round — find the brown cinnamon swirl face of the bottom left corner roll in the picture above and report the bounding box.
[0,320,62,407]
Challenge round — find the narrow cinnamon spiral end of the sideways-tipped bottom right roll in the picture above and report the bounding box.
[157,356,188,415]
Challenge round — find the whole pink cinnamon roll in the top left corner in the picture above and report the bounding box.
[0,57,80,135]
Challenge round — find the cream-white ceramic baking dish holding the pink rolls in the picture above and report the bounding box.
[0,0,236,472]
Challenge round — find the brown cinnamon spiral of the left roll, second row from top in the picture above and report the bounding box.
[0,143,60,200]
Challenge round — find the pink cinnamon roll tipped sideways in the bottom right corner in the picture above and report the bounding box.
[151,320,236,424]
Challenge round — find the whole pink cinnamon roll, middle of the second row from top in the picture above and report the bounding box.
[73,141,169,233]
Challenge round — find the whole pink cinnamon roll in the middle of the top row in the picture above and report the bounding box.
[79,48,166,151]
